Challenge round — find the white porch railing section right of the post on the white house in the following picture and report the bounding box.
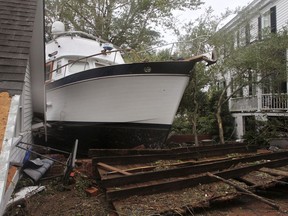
[261,94,288,111]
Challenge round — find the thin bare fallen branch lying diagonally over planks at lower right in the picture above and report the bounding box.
[207,172,280,210]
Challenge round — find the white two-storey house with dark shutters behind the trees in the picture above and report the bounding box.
[220,0,288,138]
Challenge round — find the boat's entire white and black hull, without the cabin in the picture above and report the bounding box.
[46,62,194,152]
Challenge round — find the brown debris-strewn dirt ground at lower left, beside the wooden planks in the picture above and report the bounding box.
[5,175,109,216]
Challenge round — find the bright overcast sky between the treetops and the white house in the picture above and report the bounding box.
[165,0,253,42]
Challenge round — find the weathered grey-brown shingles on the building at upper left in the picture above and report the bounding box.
[0,0,37,95]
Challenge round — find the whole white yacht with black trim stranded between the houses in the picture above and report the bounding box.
[46,22,213,151]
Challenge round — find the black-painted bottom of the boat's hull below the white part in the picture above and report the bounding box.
[35,122,171,156]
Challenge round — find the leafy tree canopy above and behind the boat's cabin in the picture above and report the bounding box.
[45,0,202,49]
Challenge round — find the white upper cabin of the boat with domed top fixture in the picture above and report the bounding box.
[46,22,124,82]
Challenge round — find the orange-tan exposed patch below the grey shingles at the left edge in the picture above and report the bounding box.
[0,92,11,151]
